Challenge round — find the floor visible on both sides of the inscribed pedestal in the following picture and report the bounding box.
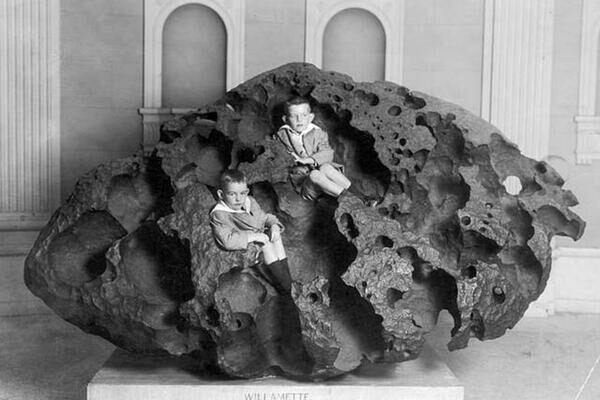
[0,314,600,400]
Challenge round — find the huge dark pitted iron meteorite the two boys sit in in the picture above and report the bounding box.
[25,64,585,379]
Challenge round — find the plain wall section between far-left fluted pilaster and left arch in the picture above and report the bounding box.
[60,0,143,198]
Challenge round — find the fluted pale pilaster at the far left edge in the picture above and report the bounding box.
[0,0,60,229]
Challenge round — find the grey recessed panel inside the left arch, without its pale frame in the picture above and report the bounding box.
[162,4,227,108]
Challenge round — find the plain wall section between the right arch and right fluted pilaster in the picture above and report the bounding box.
[403,0,484,115]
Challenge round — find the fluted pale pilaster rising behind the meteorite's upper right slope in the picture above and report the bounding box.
[481,0,554,159]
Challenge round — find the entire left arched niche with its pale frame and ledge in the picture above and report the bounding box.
[139,0,246,151]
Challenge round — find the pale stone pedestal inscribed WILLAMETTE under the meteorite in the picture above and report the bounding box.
[87,346,464,400]
